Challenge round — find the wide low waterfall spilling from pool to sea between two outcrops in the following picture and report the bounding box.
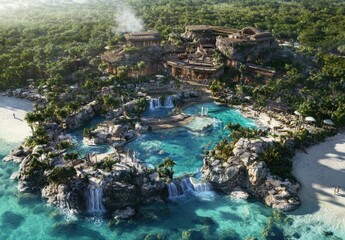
[167,177,212,200]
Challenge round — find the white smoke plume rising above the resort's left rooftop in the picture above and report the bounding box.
[115,4,144,33]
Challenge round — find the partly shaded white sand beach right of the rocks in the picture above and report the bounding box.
[292,133,345,232]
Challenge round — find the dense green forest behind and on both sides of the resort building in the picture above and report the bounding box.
[0,0,345,129]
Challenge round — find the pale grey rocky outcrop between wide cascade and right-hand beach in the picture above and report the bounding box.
[203,138,300,211]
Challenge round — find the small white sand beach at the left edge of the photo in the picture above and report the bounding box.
[0,96,33,143]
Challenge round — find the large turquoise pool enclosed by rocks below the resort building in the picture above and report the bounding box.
[127,103,255,176]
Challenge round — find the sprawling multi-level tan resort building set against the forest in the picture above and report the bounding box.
[101,25,278,84]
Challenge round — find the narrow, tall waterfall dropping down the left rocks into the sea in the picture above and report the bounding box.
[87,184,105,215]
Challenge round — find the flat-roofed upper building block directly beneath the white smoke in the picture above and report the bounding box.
[125,31,162,47]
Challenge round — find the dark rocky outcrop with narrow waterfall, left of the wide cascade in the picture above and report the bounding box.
[69,154,166,218]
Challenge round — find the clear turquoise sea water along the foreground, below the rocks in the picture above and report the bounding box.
[0,102,345,240]
